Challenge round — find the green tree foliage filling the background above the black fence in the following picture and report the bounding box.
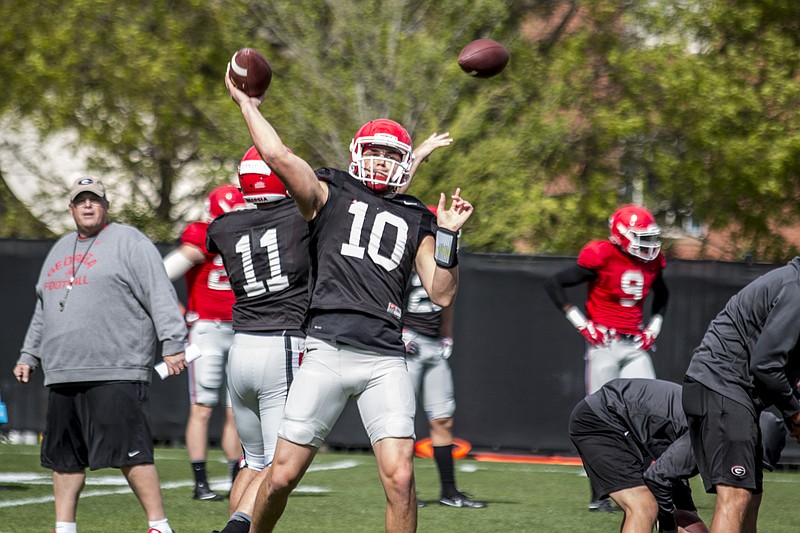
[0,0,800,259]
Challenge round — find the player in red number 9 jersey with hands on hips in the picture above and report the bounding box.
[545,205,669,511]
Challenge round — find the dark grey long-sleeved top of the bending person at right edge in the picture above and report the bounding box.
[686,257,800,417]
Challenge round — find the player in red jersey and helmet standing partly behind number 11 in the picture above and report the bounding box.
[164,185,245,501]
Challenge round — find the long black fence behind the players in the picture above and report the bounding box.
[0,240,800,462]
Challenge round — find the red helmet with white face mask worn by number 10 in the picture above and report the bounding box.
[349,118,414,192]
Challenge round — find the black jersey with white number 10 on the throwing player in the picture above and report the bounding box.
[308,168,436,356]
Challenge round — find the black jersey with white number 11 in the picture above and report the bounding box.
[207,199,309,332]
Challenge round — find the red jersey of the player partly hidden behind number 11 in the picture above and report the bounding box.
[181,222,236,322]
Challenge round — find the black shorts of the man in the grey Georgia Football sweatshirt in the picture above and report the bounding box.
[41,382,153,472]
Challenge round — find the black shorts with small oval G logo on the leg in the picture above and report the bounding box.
[683,378,764,494]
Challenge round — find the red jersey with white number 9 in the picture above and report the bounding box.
[578,241,667,334]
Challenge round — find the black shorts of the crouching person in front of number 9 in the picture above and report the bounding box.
[569,400,645,498]
